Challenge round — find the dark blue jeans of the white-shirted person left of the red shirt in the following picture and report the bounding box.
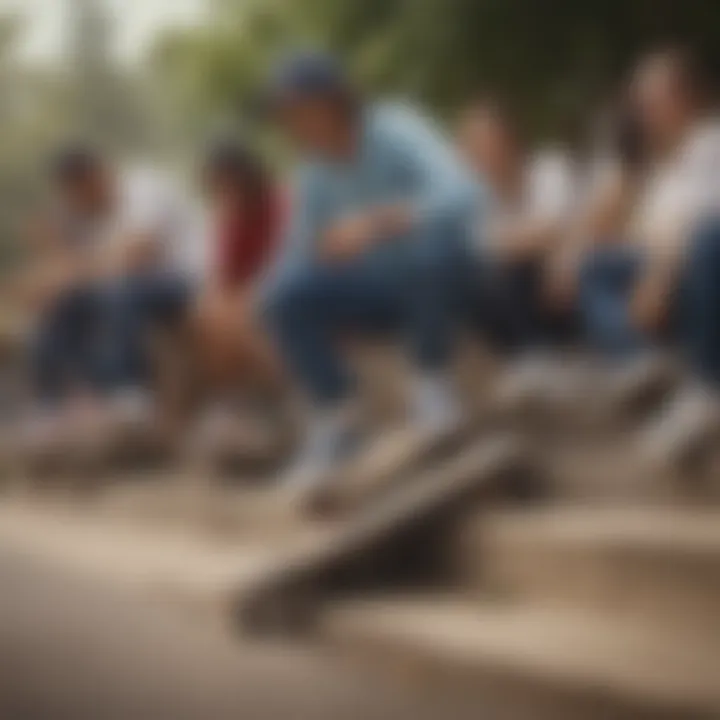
[101,272,193,390]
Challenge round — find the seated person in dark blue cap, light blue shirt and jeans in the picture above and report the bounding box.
[263,53,474,488]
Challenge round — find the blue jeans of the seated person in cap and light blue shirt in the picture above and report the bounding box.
[267,222,470,404]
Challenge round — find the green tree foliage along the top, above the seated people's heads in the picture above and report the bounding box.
[155,0,720,142]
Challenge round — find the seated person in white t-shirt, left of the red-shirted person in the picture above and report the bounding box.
[44,148,203,438]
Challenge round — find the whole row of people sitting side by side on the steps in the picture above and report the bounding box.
[12,43,720,496]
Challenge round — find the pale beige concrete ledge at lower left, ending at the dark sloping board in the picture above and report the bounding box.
[0,498,323,620]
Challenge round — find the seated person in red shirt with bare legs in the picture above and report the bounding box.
[192,142,282,436]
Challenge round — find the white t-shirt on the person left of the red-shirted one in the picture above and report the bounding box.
[105,168,208,278]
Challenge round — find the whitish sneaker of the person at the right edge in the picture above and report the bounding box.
[640,385,720,469]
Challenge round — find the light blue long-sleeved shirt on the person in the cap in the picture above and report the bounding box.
[263,103,477,295]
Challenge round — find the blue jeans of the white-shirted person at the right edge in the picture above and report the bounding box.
[581,220,720,384]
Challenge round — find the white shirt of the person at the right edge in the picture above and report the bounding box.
[630,121,720,252]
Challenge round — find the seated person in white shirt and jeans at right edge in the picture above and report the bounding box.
[581,50,720,462]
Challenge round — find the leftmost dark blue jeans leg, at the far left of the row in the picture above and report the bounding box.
[29,285,103,405]
